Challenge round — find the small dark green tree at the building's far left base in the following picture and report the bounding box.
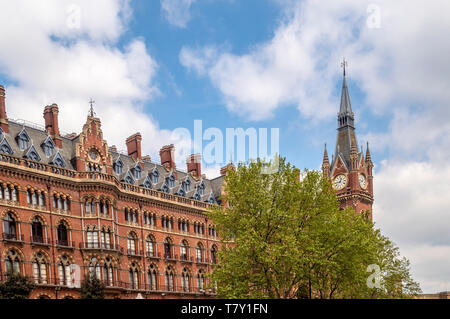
[0,272,35,299]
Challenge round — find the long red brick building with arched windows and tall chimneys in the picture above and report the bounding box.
[0,86,226,299]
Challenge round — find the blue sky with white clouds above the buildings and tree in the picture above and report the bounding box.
[0,0,450,293]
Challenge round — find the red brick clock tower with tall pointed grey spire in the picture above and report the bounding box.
[322,60,373,219]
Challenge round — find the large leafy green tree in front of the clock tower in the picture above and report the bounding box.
[210,158,420,298]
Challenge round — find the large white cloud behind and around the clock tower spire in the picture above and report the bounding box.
[180,0,450,292]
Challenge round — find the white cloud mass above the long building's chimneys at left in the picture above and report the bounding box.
[0,0,190,168]
